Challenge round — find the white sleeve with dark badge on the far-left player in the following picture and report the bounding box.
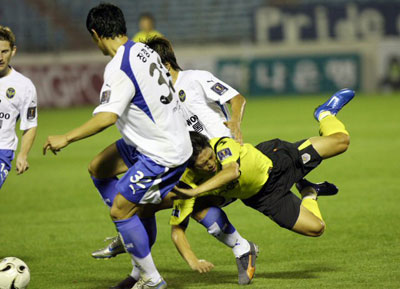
[19,84,37,130]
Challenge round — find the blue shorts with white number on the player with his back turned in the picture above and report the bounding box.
[116,139,187,204]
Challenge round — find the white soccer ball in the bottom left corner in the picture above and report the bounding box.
[0,257,31,289]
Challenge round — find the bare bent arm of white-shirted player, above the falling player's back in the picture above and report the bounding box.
[224,94,246,144]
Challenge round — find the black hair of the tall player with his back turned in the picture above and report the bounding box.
[86,3,126,39]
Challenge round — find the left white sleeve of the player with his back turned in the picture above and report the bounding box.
[93,70,135,116]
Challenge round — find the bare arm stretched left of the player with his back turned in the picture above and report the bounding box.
[43,112,118,155]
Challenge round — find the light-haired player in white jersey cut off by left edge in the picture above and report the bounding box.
[0,26,37,188]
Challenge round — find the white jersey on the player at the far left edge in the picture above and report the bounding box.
[0,68,37,151]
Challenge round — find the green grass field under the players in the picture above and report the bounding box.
[0,95,400,289]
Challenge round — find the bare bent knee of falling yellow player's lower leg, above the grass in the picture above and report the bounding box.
[292,205,325,237]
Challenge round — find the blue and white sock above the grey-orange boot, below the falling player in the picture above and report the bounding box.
[200,207,250,258]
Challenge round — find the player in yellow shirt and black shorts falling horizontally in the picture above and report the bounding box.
[171,89,354,236]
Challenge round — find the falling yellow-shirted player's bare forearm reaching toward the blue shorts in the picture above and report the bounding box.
[173,162,240,199]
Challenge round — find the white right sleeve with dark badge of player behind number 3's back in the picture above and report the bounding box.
[197,72,239,104]
